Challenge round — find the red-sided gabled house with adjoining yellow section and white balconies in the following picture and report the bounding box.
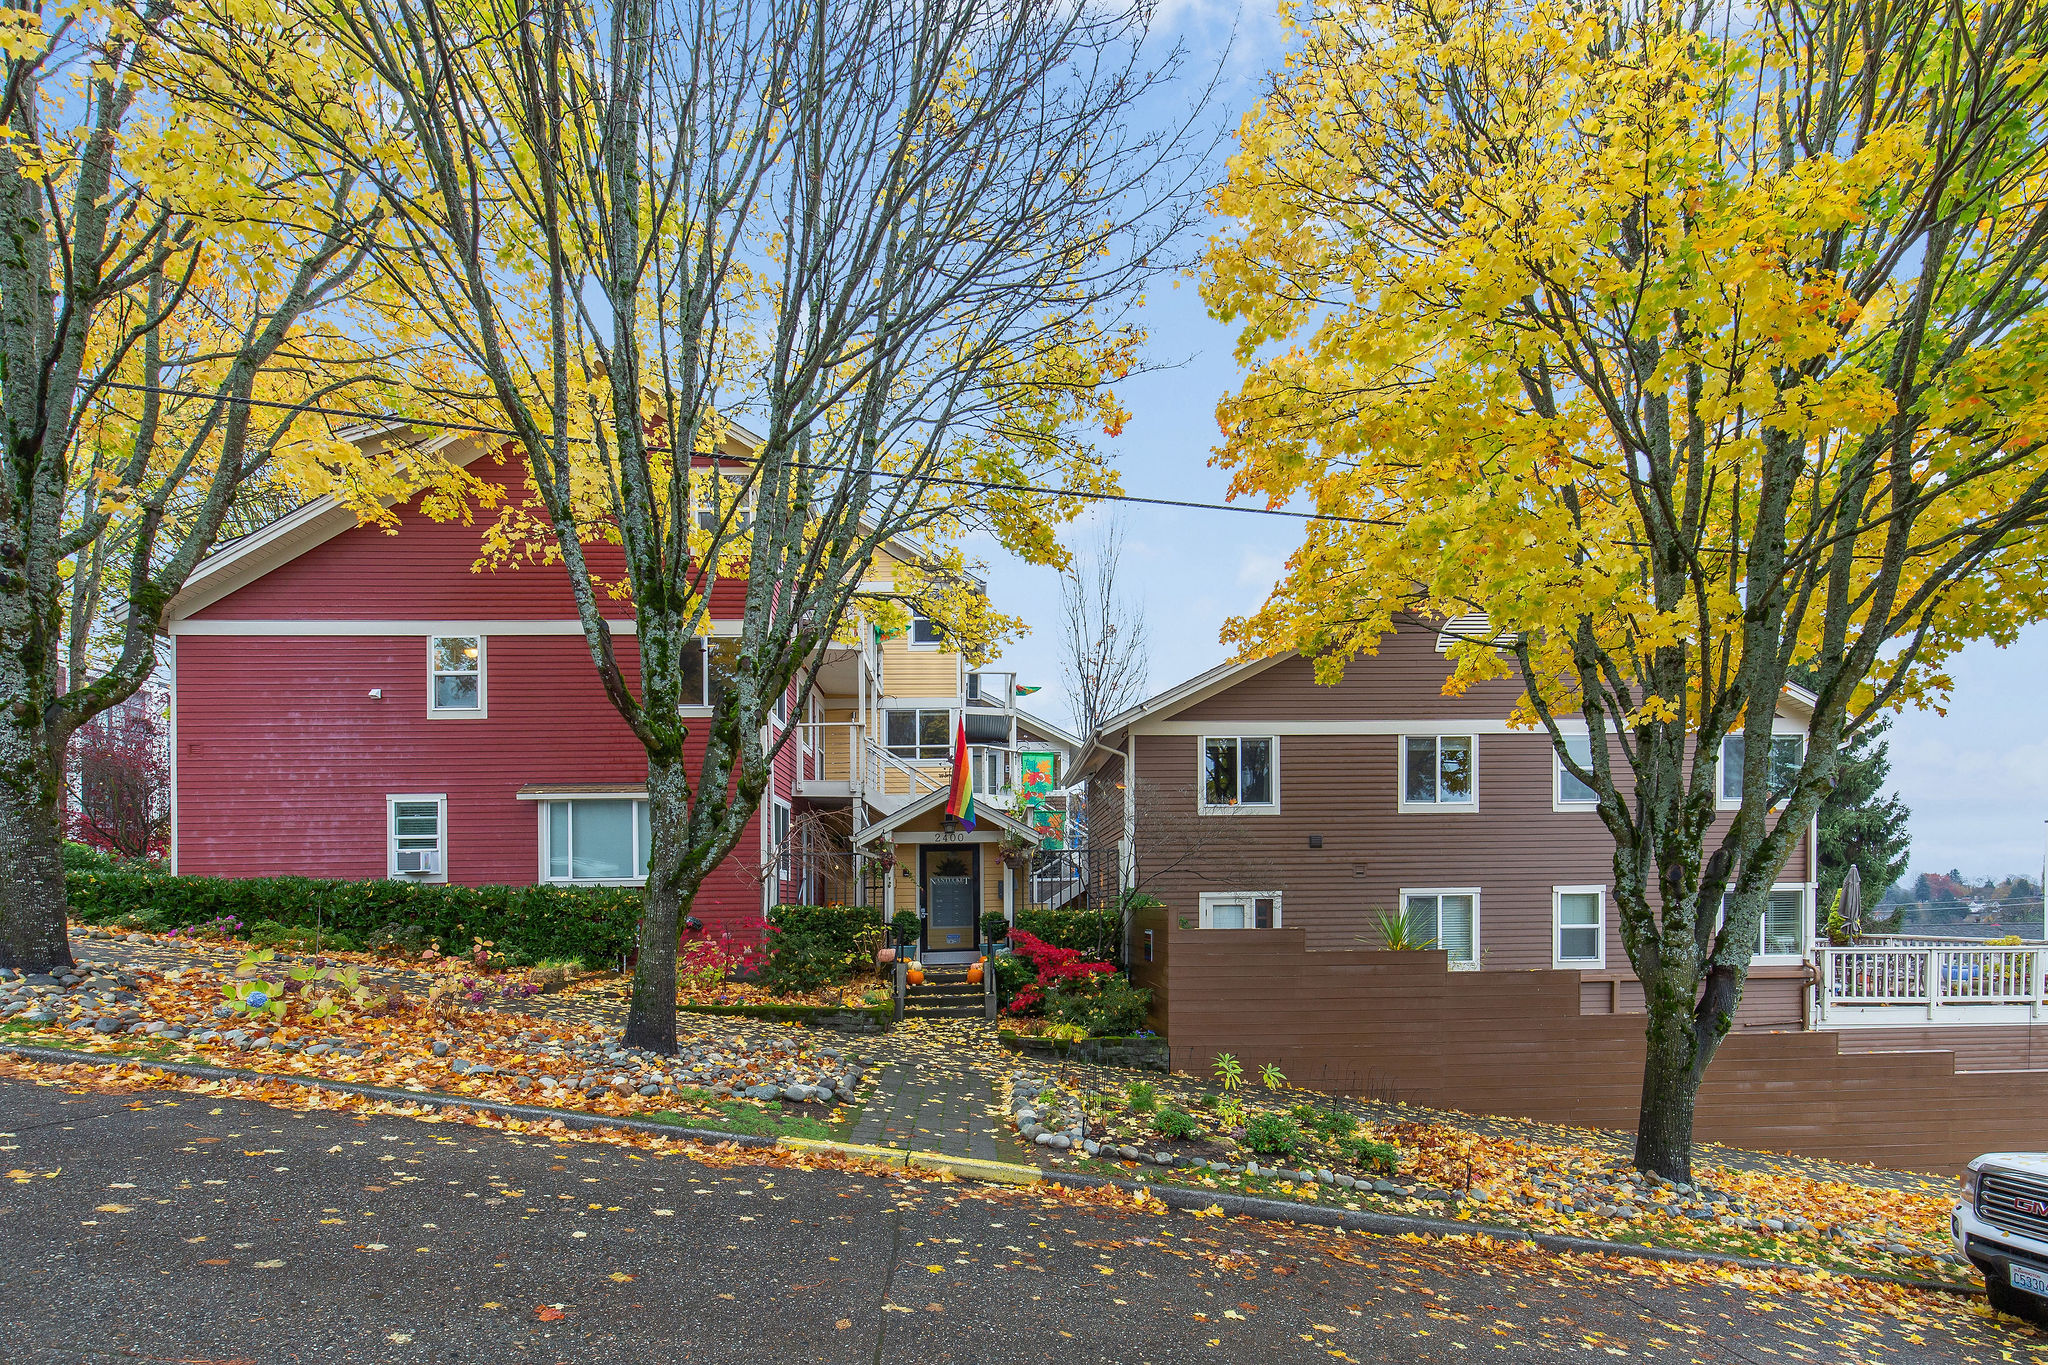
[166,442,1064,945]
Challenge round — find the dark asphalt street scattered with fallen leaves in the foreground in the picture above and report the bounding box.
[0,1081,2023,1365]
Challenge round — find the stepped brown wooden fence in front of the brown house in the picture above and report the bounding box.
[1130,911,2048,1171]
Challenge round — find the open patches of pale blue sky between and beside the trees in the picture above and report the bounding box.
[987,0,2048,878]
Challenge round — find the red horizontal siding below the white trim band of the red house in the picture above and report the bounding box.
[176,636,762,937]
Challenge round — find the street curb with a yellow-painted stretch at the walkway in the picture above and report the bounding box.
[0,1044,1985,1297]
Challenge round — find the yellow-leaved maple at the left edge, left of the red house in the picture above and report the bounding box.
[0,0,471,970]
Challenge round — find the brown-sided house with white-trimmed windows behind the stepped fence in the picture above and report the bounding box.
[1083,613,1815,1029]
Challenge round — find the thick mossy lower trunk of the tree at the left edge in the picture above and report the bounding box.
[0,692,72,972]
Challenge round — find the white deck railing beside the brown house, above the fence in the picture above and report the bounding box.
[1815,939,2048,1027]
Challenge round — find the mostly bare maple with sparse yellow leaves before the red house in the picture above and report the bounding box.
[184,0,1180,1050]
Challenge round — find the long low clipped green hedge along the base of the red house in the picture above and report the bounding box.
[63,872,641,966]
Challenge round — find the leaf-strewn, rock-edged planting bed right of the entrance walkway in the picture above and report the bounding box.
[1008,1058,1970,1283]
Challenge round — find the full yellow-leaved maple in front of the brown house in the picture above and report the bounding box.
[1204,0,2048,1179]
